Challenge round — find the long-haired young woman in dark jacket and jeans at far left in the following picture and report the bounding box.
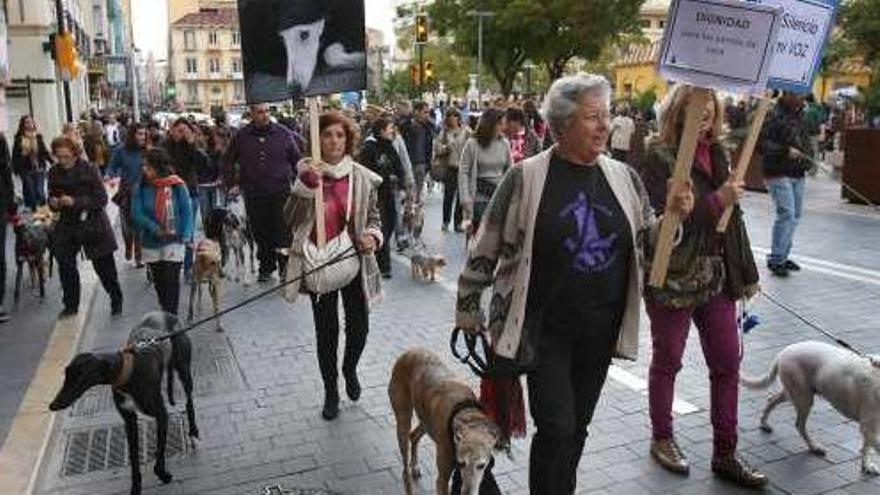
[12,115,52,210]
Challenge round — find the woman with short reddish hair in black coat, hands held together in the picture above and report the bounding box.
[49,137,122,317]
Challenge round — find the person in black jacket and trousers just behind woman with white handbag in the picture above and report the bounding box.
[358,117,404,279]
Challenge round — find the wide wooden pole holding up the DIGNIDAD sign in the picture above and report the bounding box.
[648,88,711,288]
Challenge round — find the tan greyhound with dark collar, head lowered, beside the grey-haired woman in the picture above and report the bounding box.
[388,349,501,495]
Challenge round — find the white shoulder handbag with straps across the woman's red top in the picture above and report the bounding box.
[303,175,361,295]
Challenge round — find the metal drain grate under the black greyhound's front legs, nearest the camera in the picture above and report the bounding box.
[61,415,190,476]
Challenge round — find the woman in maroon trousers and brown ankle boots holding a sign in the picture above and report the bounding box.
[642,85,767,488]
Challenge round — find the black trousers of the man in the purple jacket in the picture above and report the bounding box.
[244,191,290,275]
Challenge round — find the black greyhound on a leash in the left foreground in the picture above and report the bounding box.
[49,311,199,495]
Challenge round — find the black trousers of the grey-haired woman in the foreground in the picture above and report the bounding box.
[528,325,618,495]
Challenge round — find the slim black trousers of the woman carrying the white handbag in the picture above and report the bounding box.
[310,275,370,391]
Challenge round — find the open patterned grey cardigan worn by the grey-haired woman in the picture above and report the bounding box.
[456,148,657,366]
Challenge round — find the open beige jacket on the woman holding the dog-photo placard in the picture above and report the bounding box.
[284,160,384,304]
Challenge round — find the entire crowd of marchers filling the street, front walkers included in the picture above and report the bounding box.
[0,74,856,493]
